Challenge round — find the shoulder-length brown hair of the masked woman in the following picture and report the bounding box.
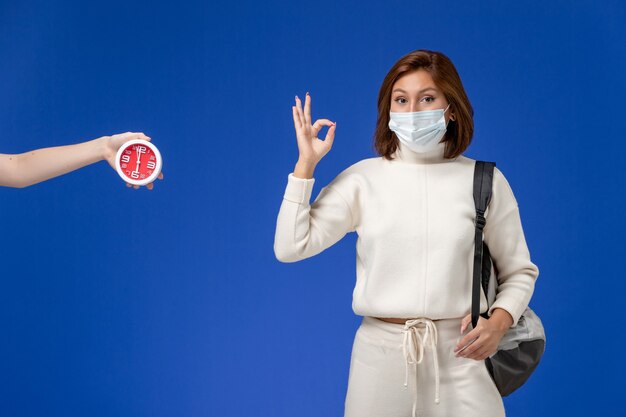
[374,49,474,159]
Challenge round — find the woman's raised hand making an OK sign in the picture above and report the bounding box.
[292,93,336,178]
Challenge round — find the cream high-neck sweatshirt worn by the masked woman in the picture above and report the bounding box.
[274,138,539,326]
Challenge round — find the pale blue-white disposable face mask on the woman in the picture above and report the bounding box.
[389,104,450,153]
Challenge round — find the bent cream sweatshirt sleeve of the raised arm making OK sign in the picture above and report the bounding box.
[274,173,355,262]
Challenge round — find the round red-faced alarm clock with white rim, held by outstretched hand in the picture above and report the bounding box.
[115,139,163,185]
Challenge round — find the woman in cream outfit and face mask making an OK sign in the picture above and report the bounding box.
[274,50,539,417]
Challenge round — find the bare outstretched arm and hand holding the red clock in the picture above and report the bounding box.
[0,132,163,190]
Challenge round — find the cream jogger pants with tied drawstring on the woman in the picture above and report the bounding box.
[344,317,505,417]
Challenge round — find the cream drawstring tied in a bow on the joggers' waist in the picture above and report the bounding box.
[402,318,439,417]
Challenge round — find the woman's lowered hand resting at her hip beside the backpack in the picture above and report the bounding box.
[454,309,512,361]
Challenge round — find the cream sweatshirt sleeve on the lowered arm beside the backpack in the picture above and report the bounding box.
[483,168,539,327]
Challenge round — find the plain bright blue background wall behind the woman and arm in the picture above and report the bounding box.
[0,0,626,417]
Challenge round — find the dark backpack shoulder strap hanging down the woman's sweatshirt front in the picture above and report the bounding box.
[472,161,496,328]
